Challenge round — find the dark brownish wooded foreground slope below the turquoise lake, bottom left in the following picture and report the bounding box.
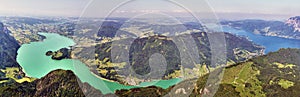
[0,70,109,97]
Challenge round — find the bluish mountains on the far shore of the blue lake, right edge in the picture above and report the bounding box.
[221,16,300,39]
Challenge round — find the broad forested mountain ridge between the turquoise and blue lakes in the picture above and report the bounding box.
[76,32,264,85]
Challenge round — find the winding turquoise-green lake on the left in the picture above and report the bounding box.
[17,33,181,94]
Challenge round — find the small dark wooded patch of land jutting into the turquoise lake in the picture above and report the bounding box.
[46,48,71,60]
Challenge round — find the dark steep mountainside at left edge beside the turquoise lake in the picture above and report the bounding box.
[0,22,20,68]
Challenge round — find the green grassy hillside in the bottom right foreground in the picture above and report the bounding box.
[117,49,300,97]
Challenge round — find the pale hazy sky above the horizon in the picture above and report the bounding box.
[0,0,300,18]
